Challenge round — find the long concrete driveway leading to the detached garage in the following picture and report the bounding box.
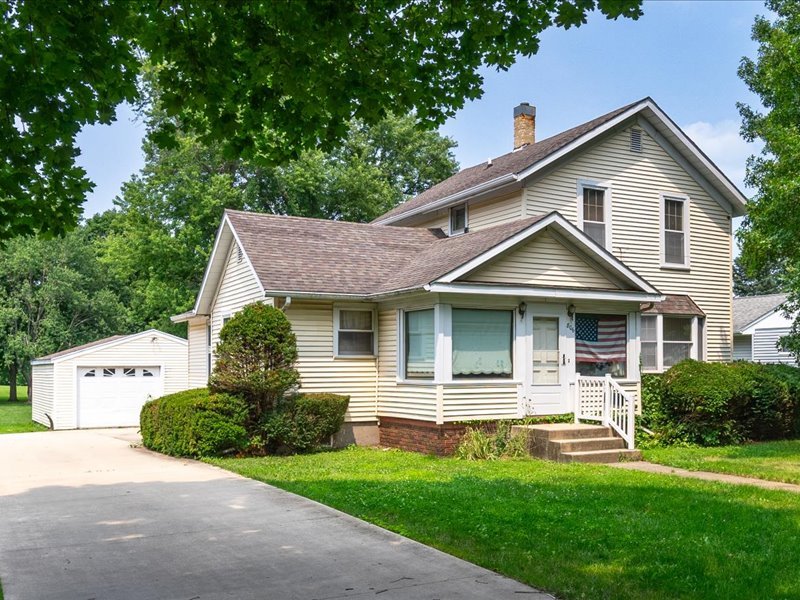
[0,430,550,600]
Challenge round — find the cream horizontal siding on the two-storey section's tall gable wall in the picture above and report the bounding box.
[525,130,733,360]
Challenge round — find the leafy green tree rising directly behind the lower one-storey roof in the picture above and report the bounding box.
[103,109,457,333]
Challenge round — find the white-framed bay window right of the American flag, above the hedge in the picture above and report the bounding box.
[640,315,702,371]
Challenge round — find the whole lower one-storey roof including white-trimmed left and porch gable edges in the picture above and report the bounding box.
[173,211,660,322]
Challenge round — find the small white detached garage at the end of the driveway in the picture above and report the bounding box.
[31,329,188,429]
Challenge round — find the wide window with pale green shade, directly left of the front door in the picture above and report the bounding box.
[452,308,514,379]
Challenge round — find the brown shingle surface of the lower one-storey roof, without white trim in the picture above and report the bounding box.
[226,210,541,296]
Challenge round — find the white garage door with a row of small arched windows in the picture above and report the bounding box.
[78,367,164,427]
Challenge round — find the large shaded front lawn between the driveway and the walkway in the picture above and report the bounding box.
[211,448,800,599]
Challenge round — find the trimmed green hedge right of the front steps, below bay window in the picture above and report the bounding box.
[642,360,800,446]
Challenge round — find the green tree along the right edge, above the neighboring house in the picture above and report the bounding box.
[739,0,800,355]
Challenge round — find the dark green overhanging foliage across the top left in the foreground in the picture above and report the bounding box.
[0,0,641,238]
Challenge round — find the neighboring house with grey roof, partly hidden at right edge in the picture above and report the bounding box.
[733,294,796,365]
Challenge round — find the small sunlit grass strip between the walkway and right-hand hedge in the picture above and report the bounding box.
[644,440,800,484]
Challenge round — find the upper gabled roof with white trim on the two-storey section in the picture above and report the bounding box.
[373,97,747,225]
